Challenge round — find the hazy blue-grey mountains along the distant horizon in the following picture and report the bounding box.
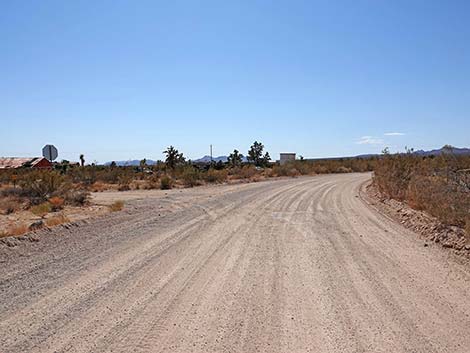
[104,147,470,167]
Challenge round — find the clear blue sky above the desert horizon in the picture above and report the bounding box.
[0,0,470,162]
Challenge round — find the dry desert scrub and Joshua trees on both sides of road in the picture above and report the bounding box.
[0,141,470,238]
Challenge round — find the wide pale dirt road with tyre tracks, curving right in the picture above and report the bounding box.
[0,174,470,353]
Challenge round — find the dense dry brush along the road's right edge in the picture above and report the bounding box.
[374,153,470,228]
